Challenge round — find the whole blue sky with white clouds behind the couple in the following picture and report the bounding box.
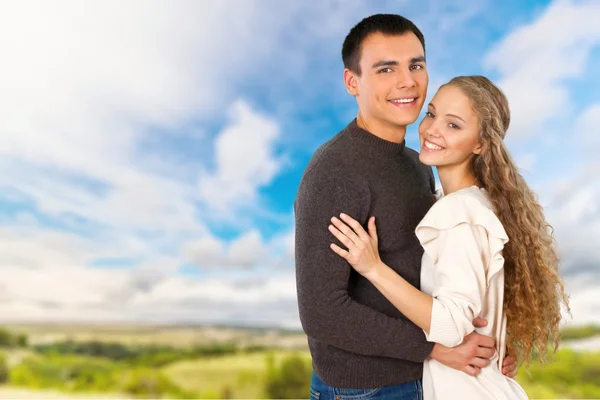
[0,0,600,327]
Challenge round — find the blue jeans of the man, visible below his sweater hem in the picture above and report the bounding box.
[310,372,423,400]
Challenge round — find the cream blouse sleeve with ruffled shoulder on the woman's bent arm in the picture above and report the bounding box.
[416,191,508,347]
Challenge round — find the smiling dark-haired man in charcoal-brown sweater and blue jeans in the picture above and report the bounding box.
[295,14,516,400]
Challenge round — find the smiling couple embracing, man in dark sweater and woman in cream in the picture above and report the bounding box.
[294,14,568,400]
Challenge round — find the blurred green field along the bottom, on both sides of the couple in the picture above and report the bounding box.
[0,325,600,399]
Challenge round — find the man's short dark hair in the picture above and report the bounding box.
[342,14,425,75]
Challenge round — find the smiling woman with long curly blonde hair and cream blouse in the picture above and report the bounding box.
[329,76,568,399]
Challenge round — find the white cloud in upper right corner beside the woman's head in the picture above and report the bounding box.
[484,0,600,138]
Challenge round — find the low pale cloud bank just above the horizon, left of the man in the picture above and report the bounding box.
[0,222,298,325]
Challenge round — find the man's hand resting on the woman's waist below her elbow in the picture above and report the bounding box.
[431,332,496,376]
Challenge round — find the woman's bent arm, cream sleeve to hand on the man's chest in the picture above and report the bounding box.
[329,214,486,347]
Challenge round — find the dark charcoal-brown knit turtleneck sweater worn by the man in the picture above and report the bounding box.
[294,120,435,388]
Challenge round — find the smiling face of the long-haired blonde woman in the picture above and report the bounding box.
[419,85,482,170]
